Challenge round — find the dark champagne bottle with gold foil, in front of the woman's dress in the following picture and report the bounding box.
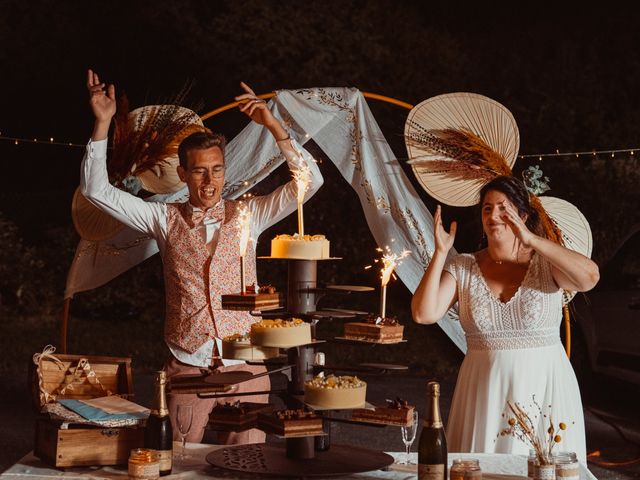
[418,382,447,480]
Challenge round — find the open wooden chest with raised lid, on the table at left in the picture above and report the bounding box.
[29,354,144,468]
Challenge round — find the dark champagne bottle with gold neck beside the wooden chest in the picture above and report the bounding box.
[144,370,173,476]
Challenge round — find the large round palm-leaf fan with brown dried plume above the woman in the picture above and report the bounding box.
[405,92,520,207]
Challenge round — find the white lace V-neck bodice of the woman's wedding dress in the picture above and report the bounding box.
[445,254,562,350]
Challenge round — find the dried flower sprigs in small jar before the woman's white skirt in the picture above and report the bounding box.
[500,395,567,465]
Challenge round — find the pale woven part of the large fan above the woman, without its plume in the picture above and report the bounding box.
[404,92,520,207]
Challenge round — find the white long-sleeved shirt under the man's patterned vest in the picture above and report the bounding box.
[80,139,323,367]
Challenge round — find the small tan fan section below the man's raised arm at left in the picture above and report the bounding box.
[71,187,124,242]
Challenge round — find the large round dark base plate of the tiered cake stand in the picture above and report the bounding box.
[206,443,393,477]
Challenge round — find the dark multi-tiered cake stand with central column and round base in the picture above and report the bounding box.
[172,257,406,477]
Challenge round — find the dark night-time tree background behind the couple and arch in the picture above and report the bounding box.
[0,0,640,370]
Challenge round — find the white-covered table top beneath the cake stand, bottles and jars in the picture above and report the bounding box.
[0,443,596,480]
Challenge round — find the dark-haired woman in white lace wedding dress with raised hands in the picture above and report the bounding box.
[411,176,599,461]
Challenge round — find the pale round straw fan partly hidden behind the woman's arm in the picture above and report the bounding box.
[539,196,593,303]
